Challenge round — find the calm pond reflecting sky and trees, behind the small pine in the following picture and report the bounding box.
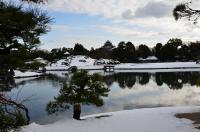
[3,72,200,124]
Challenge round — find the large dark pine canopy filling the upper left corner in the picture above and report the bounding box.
[0,0,52,71]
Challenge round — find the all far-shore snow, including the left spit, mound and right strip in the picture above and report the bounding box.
[11,55,200,78]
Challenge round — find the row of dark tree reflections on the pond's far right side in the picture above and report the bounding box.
[104,72,200,89]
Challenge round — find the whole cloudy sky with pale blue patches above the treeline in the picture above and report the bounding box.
[40,0,200,47]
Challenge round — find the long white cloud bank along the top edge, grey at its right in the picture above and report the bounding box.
[48,0,177,19]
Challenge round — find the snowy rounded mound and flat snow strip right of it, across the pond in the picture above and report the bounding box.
[46,55,200,71]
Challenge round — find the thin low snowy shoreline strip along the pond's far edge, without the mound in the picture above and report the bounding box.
[14,62,200,78]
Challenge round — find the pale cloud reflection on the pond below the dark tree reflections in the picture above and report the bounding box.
[110,80,200,106]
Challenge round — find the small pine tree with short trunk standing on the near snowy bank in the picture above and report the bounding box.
[47,71,109,120]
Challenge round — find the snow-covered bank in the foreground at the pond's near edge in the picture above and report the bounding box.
[21,106,200,132]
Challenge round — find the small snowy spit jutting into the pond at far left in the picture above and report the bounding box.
[14,70,42,78]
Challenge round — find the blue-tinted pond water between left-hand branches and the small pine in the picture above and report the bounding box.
[0,75,62,122]
